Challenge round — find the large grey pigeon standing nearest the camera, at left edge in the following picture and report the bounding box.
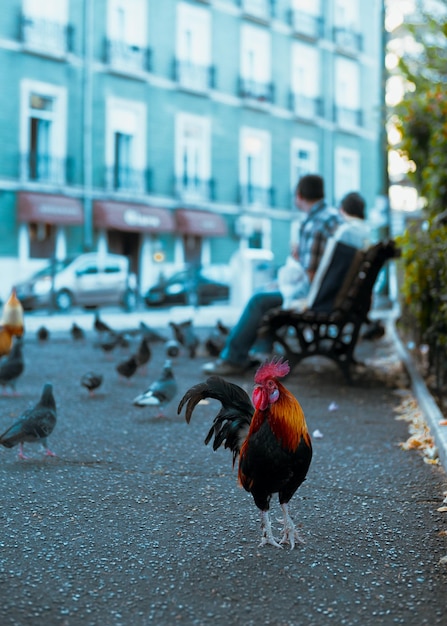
[0,383,56,459]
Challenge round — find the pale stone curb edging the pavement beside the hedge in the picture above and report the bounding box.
[387,319,447,472]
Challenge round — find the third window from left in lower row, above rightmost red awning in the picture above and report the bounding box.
[175,113,213,200]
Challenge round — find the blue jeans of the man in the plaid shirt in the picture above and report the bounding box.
[220,291,283,366]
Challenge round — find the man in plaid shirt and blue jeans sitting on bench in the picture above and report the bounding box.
[202,174,342,376]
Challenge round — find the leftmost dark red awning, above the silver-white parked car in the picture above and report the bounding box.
[17,191,84,226]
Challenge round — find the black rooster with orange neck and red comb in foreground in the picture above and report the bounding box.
[178,358,312,549]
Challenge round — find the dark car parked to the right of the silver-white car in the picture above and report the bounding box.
[144,270,230,306]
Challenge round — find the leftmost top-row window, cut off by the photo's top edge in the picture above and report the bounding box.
[22,0,70,55]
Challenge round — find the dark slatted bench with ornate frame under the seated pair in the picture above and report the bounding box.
[260,240,399,383]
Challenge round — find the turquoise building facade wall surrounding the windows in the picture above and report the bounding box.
[0,0,383,298]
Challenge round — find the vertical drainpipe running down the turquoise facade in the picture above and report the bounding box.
[83,0,93,250]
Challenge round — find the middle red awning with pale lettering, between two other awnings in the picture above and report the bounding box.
[93,200,175,233]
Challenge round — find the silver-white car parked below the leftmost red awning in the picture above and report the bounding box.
[15,253,137,311]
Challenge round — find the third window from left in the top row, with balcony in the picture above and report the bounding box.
[175,2,212,90]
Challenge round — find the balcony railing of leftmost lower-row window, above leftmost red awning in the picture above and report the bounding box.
[21,152,73,185]
